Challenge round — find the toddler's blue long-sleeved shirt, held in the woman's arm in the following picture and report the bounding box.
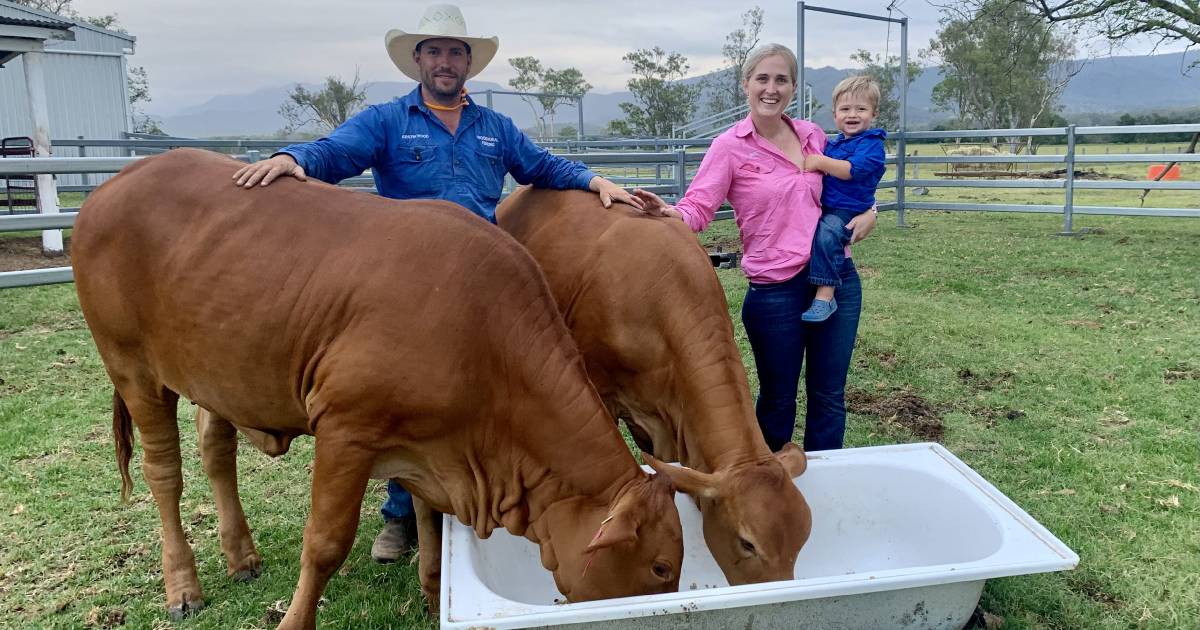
[821,128,888,215]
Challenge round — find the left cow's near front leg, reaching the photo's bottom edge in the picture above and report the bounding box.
[280,432,376,630]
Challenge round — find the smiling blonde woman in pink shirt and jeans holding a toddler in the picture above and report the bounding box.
[635,44,876,451]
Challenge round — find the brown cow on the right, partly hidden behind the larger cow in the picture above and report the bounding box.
[497,188,812,584]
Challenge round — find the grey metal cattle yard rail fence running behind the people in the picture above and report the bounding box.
[0,124,1200,289]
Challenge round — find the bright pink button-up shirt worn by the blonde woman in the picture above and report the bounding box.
[676,116,826,282]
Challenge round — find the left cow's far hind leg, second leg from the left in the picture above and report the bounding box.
[196,407,263,582]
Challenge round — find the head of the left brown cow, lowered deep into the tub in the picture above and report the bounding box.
[541,473,683,601]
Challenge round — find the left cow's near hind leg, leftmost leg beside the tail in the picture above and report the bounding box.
[122,388,204,620]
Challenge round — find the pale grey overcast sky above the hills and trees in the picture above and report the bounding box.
[74,0,1190,115]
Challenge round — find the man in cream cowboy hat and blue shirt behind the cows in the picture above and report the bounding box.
[233,5,642,563]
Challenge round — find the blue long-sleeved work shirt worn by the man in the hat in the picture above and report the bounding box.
[278,86,595,223]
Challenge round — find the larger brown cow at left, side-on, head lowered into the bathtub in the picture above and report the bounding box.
[72,150,683,628]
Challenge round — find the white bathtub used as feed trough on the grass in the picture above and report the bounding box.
[442,444,1079,630]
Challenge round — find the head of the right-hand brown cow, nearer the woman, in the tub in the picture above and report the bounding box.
[644,444,812,586]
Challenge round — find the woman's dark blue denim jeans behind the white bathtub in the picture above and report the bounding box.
[742,258,863,451]
